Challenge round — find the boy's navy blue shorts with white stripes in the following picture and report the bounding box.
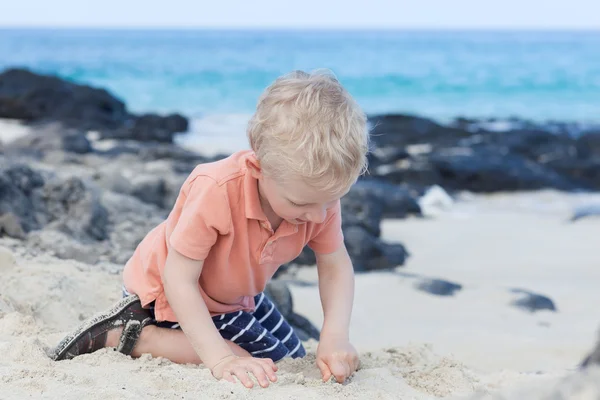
[123,288,306,362]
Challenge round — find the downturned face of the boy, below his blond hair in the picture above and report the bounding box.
[245,157,346,224]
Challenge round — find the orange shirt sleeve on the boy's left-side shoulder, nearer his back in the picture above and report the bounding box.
[169,176,231,260]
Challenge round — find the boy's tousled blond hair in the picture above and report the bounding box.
[247,71,369,193]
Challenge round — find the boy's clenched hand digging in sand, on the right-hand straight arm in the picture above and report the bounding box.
[317,338,359,383]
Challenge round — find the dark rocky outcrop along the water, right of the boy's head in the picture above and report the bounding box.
[370,115,600,192]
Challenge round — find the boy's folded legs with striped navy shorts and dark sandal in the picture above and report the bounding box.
[53,294,306,364]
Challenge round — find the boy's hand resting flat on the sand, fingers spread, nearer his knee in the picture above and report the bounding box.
[211,356,278,389]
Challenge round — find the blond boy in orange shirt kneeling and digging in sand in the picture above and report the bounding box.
[53,72,368,388]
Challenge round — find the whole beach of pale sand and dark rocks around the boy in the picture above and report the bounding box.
[0,57,600,400]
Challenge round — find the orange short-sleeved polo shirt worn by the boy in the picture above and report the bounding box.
[123,151,343,322]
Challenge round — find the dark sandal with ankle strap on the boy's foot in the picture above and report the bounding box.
[51,295,153,361]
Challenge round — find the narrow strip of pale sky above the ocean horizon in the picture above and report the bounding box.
[0,0,600,29]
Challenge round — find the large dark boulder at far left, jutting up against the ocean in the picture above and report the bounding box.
[0,68,188,143]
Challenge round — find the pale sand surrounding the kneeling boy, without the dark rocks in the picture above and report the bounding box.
[0,192,600,400]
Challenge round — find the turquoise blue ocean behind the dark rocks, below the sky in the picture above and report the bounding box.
[0,29,600,153]
